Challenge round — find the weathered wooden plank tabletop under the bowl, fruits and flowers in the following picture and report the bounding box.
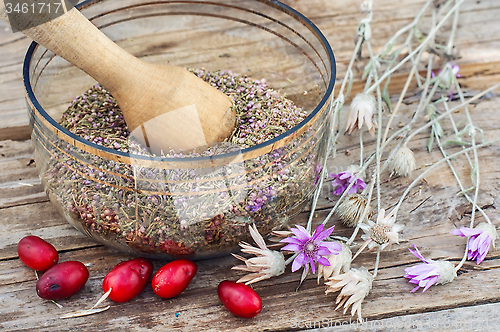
[0,0,500,331]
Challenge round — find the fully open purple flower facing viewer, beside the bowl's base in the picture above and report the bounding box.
[280,225,342,273]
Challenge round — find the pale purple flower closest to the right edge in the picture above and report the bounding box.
[450,223,497,265]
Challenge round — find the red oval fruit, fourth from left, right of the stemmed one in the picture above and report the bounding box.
[151,259,198,299]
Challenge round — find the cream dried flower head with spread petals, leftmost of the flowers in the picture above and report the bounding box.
[232,224,286,285]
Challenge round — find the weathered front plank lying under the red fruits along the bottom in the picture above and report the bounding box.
[0,240,500,331]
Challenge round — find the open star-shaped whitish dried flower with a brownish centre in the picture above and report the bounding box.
[359,209,404,250]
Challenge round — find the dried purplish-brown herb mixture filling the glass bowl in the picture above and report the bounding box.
[42,70,322,258]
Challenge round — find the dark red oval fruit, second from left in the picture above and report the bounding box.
[36,261,89,300]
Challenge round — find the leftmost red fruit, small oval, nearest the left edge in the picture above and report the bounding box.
[17,235,59,271]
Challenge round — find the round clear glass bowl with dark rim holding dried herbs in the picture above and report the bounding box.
[23,0,335,259]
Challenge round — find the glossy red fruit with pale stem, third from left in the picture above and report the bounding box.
[102,258,153,302]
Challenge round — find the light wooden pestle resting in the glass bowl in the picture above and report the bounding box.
[0,0,236,154]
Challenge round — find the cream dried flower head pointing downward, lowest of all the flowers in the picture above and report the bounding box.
[325,267,373,319]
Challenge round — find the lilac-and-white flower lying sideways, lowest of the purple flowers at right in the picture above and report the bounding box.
[404,245,457,293]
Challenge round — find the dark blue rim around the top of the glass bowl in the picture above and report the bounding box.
[22,0,336,165]
